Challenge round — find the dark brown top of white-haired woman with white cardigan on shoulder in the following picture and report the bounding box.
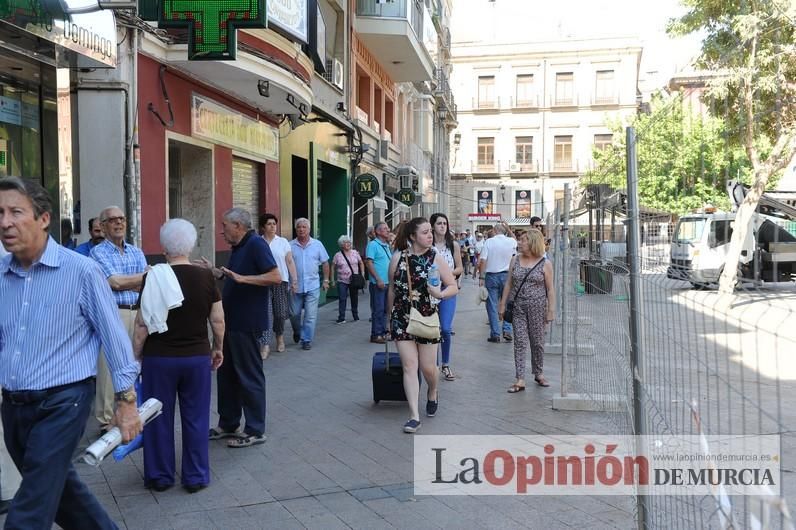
[141,265,221,357]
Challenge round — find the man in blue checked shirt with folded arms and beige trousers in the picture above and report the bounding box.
[90,206,147,431]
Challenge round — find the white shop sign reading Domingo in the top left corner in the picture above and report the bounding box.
[0,0,116,67]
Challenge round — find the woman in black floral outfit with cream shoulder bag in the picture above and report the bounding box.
[387,217,459,433]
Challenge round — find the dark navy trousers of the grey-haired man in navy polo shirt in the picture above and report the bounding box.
[216,329,265,436]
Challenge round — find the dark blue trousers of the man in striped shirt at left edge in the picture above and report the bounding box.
[2,379,118,530]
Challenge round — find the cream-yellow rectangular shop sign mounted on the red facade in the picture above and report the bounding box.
[191,94,279,160]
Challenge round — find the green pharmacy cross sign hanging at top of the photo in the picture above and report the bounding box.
[155,0,266,61]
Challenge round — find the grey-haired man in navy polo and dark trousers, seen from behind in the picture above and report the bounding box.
[202,208,282,447]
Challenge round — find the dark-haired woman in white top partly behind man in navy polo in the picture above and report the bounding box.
[259,213,298,359]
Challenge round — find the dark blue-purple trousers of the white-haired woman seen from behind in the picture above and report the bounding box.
[141,355,212,486]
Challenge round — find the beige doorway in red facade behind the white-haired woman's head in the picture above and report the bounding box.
[167,140,215,262]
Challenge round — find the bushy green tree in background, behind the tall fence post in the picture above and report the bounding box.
[584,94,752,213]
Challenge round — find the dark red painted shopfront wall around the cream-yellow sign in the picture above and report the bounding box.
[138,55,279,254]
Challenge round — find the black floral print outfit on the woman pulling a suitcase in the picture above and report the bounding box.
[391,248,440,344]
